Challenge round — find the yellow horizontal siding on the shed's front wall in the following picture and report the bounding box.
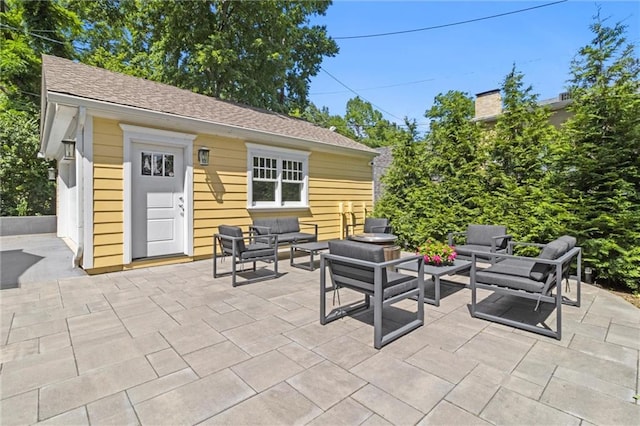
[90,118,373,273]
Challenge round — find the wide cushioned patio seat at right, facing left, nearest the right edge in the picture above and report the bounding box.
[470,235,582,340]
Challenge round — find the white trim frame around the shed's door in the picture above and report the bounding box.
[120,124,197,265]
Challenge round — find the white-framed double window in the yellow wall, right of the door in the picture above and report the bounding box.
[247,143,310,208]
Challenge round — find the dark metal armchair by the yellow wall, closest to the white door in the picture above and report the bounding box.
[213,225,278,287]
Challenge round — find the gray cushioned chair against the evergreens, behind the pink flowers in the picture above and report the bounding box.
[448,225,511,263]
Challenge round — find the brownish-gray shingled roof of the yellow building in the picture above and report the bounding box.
[42,55,375,153]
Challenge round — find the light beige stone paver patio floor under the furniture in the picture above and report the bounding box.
[0,255,640,426]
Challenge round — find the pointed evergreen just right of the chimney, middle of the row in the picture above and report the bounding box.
[480,66,571,242]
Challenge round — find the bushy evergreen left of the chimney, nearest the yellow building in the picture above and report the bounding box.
[376,91,484,248]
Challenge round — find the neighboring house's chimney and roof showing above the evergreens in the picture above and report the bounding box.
[474,89,571,127]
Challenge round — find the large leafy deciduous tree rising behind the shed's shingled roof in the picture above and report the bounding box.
[70,0,338,112]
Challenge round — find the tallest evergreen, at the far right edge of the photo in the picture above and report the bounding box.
[562,15,640,292]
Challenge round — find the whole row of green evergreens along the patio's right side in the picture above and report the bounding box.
[375,17,640,292]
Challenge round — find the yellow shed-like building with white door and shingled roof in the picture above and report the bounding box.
[41,56,377,273]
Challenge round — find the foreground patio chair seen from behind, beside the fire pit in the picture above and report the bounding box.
[320,240,424,349]
